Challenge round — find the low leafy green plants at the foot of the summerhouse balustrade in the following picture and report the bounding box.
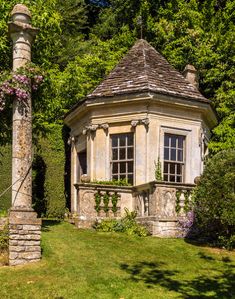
[95,209,149,237]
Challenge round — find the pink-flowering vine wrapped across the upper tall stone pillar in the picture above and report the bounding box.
[0,63,44,112]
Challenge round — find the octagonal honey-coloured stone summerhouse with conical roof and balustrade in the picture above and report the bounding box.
[65,39,217,236]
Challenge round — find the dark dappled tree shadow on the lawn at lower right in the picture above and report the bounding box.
[120,253,235,299]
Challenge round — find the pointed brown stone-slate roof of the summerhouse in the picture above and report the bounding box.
[87,39,210,102]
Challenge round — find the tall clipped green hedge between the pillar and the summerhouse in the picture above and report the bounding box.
[33,125,65,218]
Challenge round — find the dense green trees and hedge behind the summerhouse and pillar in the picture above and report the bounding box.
[0,0,235,216]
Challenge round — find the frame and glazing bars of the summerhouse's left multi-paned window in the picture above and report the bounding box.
[109,132,135,185]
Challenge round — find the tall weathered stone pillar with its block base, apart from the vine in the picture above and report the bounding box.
[8,4,41,265]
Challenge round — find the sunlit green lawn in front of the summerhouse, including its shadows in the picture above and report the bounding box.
[0,222,235,299]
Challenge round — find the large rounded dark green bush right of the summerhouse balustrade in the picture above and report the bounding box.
[194,150,235,248]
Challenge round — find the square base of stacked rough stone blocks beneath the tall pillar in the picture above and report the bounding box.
[9,208,42,266]
